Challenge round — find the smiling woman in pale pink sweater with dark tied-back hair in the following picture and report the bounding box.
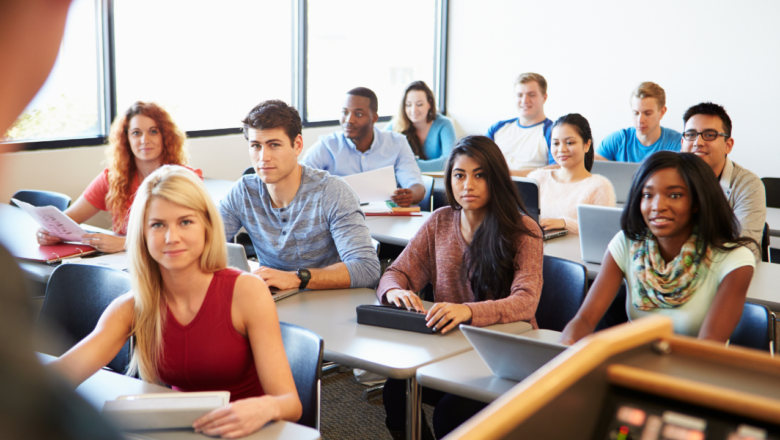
[528,113,616,234]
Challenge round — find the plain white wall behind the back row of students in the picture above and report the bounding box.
[447,0,780,177]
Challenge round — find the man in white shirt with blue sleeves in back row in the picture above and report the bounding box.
[487,72,556,177]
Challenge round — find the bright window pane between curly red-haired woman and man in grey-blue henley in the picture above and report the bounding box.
[114,0,292,131]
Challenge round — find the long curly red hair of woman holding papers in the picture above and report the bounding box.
[106,101,187,231]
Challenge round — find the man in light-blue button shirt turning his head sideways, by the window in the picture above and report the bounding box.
[301,87,425,206]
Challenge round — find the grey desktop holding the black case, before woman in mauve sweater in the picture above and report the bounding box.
[276,289,531,379]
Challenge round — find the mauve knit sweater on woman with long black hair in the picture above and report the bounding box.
[376,207,543,328]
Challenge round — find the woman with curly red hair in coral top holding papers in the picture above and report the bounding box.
[37,101,203,252]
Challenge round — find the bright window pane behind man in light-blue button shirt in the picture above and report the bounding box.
[305,0,437,122]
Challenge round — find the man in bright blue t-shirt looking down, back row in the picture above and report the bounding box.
[596,81,682,163]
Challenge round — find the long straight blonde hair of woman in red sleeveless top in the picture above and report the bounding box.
[127,165,227,383]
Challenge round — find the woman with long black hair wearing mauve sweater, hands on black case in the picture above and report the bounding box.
[377,136,543,438]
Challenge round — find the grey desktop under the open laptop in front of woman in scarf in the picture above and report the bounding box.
[417,330,561,403]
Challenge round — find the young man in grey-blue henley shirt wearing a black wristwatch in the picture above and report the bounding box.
[219,100,379,289]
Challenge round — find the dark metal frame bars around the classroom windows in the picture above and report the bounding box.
[0,0,449,151]
